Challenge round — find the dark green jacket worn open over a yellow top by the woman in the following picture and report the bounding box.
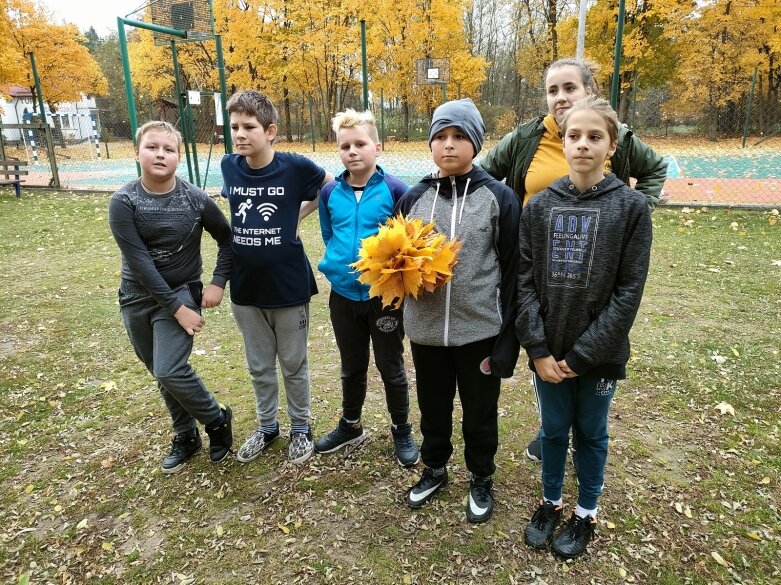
[480,116,667,210]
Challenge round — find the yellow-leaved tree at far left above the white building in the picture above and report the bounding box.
[0,0,108,111]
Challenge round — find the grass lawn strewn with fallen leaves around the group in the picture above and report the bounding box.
[0,190,781,585]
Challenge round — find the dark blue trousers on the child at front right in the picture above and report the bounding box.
[534,374,616,510]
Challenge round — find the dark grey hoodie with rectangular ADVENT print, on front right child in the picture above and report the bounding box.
[516,173,651,380]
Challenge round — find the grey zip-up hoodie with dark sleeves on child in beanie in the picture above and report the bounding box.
[396,167,521,378]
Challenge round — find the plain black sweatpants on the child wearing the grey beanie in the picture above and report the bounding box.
[411,337,501,477]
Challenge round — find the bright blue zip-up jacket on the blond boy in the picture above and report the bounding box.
[317,166,407,301]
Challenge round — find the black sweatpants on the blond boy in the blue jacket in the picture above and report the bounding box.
[328,291,409,425]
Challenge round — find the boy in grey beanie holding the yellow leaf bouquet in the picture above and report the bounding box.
[396,99,521,523]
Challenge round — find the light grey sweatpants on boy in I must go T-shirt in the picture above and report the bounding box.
[231,303,311,426]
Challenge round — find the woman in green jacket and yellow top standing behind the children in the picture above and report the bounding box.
[480,58,667,461]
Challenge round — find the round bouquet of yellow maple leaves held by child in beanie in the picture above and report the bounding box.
[351,215,461,308]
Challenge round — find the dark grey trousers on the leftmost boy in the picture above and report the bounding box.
[119,282,220,434]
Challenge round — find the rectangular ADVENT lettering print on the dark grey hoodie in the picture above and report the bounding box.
[548,207,599,288]
